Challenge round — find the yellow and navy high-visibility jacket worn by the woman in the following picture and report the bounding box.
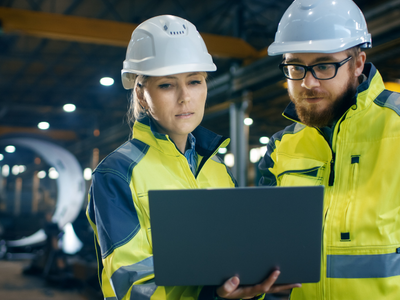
[86,118,236,300]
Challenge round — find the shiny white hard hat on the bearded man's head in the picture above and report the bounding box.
[268,0,372,55]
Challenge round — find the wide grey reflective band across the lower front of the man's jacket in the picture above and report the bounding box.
[326,253,400,278]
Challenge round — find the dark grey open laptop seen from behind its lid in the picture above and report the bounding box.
[149,186,324,286]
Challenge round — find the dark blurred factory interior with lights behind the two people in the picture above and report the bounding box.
[0,0,400,300]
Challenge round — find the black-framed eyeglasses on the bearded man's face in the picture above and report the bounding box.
[279,56,352,80]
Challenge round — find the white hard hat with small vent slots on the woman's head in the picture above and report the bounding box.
[121,15,217,89]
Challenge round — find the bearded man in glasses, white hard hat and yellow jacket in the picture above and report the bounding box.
[259,0,400,300]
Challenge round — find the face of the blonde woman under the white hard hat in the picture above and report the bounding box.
[136,72,207,141]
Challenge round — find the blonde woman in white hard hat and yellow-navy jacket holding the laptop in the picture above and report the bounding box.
[87,16,296,299]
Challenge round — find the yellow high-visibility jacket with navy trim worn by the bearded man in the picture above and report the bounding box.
[259,64,400,300]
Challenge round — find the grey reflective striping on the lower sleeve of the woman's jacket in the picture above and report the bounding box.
[111,256,155,299]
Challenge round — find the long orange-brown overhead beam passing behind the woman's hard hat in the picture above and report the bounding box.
[0,7,258,59]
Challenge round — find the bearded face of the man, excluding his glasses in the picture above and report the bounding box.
[284,51,363,127]
